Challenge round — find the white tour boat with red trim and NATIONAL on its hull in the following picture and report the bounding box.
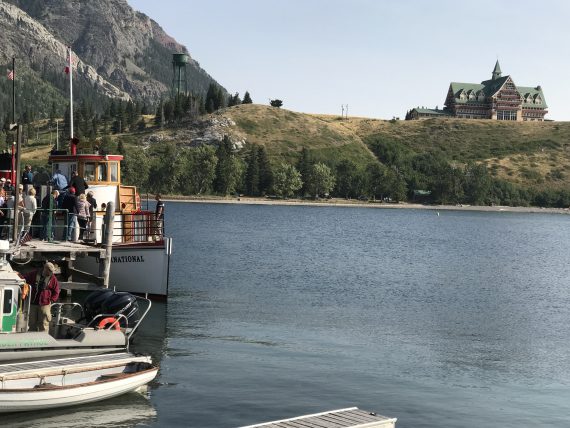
[49,149,172,299]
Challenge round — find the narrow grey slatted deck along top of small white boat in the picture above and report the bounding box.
[0,352,144,379]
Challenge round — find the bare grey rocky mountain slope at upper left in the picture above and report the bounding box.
[0,0,221,101]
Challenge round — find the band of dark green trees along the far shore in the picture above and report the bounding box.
[115,137,570,207]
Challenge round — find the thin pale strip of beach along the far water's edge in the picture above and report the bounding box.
[155,195,570,214]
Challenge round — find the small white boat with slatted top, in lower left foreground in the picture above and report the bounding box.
[0,353,158,413]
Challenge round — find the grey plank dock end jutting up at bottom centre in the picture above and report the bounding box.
[241,407,397,428]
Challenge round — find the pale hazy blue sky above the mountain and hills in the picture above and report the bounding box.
[128,0,570,120]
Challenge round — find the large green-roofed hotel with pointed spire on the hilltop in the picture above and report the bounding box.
[406,61,548,122]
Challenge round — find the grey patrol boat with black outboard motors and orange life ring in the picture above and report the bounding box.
[0,251,151,363]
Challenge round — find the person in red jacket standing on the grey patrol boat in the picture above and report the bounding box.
[24,262,59,331]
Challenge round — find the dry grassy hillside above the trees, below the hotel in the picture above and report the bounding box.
[20,104,570,189]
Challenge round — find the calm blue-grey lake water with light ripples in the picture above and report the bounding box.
[3,202,570,428]
